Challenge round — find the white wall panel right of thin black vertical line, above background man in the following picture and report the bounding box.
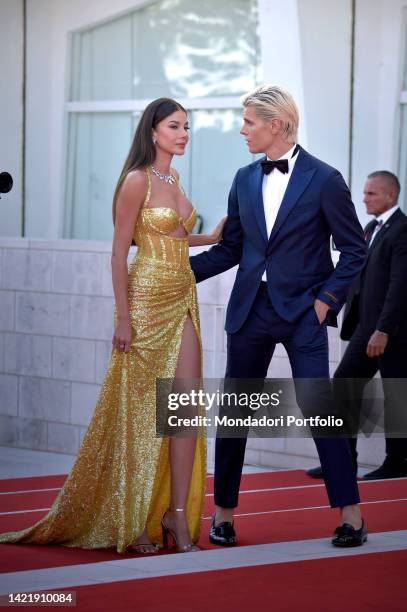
[352,0,407,222]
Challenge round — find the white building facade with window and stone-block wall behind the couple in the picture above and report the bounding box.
[0,0,407,466]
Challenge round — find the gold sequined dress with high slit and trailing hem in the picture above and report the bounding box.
[0,171,206,552]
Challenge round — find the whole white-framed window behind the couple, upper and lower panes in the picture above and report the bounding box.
[65,0,259,240]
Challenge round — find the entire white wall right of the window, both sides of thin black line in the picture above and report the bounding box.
[259,0,407,223]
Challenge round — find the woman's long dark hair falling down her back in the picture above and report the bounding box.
[113,98,187,225]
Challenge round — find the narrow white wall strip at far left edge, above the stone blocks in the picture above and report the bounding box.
[0,0,23,236]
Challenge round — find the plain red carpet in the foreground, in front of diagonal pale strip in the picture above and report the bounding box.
[57,551,407,612]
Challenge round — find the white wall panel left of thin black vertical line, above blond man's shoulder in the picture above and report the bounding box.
[298,0,352,180]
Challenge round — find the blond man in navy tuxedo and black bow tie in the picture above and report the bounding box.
[191,86,367,546]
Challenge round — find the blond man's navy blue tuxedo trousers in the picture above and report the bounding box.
[214,282,359,508]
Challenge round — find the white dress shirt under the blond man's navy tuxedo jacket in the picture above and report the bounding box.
[261,145,298,281]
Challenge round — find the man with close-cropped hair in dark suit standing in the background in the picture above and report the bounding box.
[307,170,407,480]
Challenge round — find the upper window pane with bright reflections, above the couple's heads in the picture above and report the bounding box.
[71,0,258,100]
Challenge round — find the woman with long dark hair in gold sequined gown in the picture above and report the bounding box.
[0,98,226,553]
